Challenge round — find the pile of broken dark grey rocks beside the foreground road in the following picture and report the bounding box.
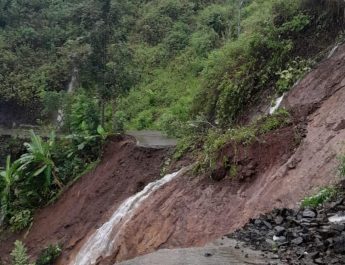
[228,194,345,265]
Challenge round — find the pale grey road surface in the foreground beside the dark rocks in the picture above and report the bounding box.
[117,237,282,265]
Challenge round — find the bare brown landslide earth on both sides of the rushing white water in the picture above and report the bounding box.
[0,42,345,265]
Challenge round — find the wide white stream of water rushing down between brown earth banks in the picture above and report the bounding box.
[69,169,184,265]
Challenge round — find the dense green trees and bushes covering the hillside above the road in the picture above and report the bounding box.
[0,0,345,136]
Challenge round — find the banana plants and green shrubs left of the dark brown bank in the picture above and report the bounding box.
[0,129,107,232]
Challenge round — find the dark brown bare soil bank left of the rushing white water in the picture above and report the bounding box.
[0,136,168,264]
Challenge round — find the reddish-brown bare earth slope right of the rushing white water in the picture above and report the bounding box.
[97,45,345,264]
